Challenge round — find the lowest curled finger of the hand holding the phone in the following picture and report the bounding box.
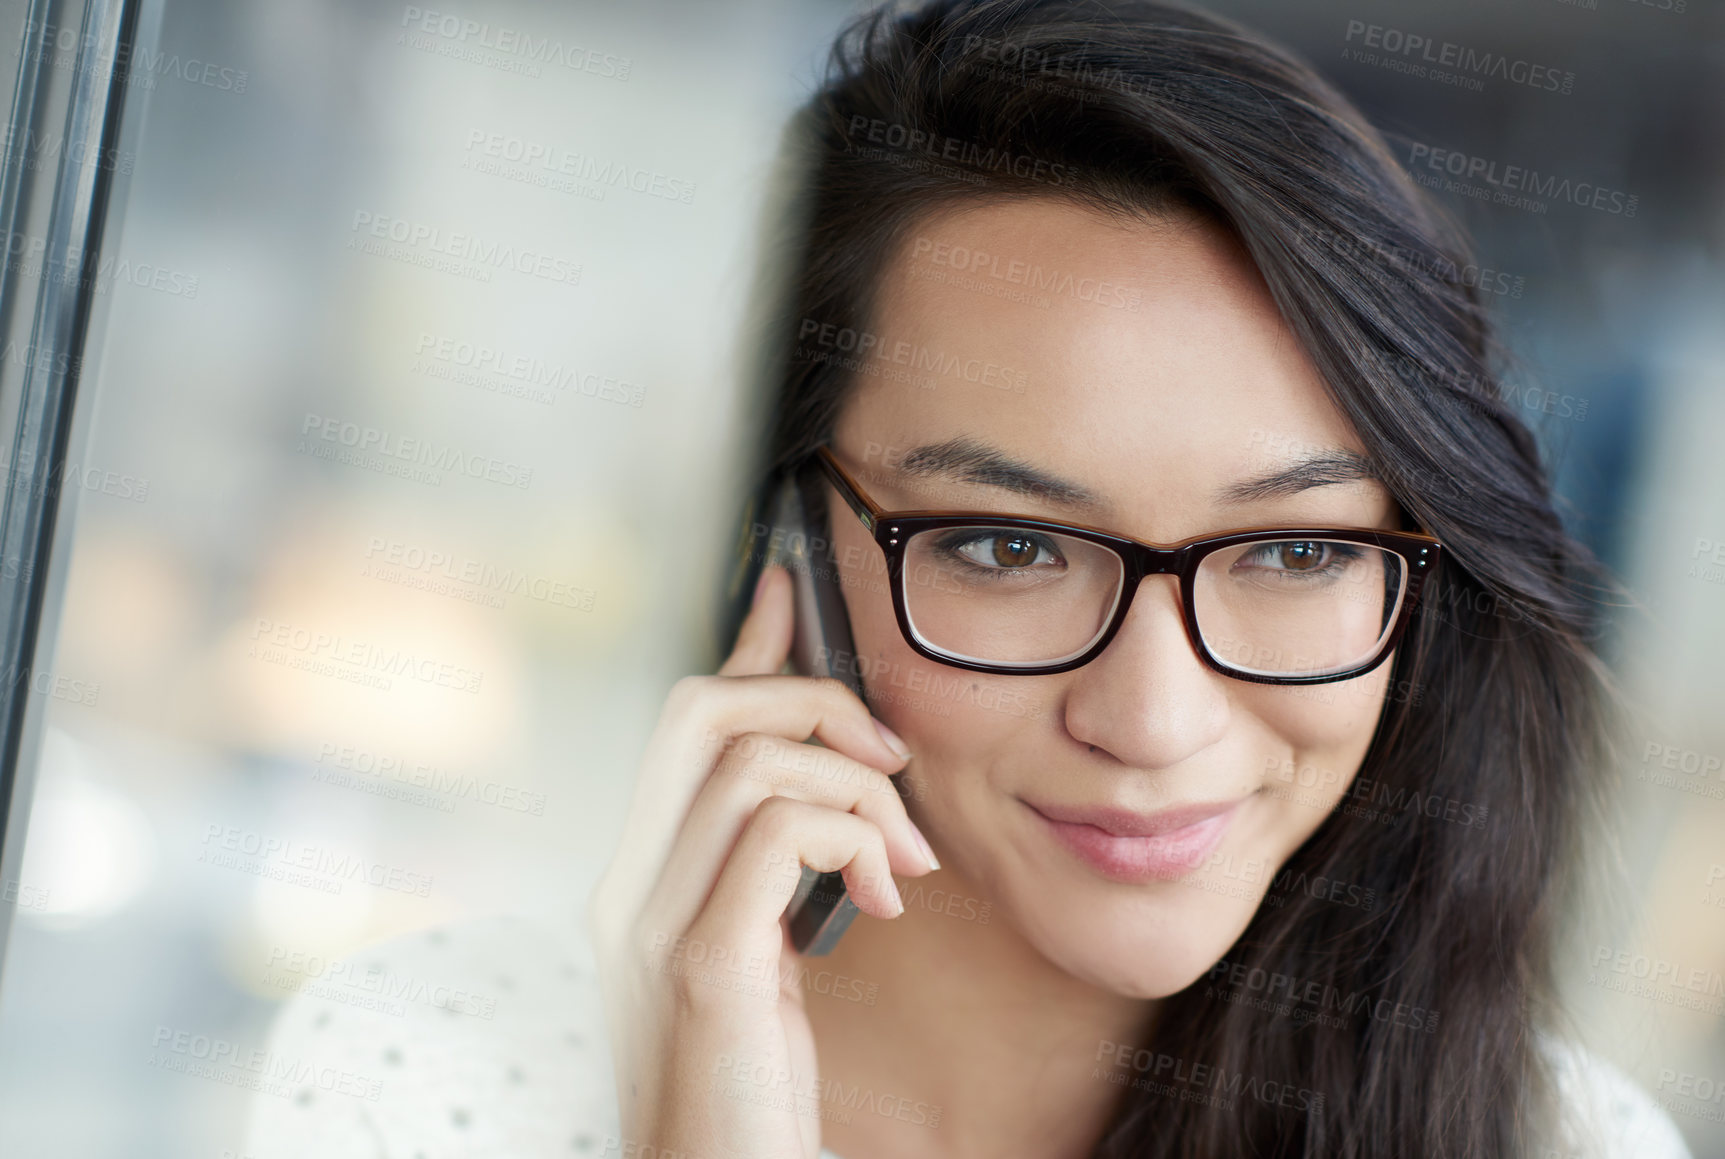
[688,797,904,961]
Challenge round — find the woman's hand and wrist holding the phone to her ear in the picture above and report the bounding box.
[588,567,935,1159]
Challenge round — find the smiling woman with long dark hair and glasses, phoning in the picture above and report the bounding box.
[592,0,1687,1159]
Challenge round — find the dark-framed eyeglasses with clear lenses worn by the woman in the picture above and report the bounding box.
[814,447,1444,685]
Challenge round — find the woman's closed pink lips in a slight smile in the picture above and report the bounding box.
[1025,799,1244,885]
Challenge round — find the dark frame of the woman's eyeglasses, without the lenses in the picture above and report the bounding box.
[814,445,1444,685]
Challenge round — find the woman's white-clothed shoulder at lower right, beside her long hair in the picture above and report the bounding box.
[1539,1035,1692,1159]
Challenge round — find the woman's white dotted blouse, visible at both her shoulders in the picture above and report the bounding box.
[243,918,1692,1159]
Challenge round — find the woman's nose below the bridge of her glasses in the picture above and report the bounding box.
[1064,576,1228,769]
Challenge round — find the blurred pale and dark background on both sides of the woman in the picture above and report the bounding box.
[0,0,1725,1159]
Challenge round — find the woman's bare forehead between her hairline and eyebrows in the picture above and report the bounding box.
[837,200,1363,534]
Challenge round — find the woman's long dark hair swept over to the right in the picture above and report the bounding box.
[726,0,1609,1159]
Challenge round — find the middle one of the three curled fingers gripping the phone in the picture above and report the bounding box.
[647,733,935,930]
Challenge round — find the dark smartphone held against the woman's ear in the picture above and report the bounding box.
[757,465,863,957]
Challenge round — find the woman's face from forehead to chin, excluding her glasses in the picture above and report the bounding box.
[821,200,1396,997]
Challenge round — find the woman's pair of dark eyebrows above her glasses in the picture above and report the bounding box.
[897,436,1380,511]
